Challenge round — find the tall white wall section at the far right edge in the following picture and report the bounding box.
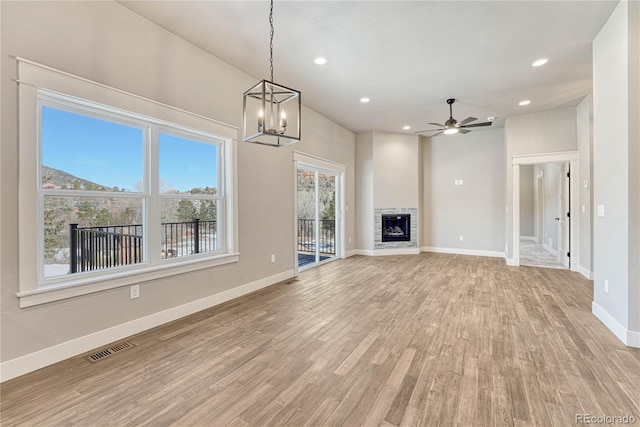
[593,2,640,347]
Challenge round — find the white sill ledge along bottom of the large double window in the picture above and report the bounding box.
[17,253,240,308]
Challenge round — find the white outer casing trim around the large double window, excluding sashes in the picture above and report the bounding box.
[16,58,240,308]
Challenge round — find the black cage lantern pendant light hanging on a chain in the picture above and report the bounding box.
[242,0,302,147]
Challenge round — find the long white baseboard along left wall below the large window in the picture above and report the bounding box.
[0,270,293,382]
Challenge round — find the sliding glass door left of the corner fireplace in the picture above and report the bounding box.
[295,153,343,270]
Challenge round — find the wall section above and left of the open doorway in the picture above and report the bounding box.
[505,108,578,258]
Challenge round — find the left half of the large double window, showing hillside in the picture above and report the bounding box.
[38,102,150,285]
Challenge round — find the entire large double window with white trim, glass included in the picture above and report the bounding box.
[18,59,238,307]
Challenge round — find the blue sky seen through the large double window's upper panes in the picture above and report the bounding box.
[42,107,217,191]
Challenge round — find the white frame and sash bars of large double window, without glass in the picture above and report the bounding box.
[17,58,239,307]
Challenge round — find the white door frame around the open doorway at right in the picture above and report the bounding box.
[510,151,580,271]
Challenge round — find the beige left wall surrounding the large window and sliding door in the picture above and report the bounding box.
[0,2,355,368]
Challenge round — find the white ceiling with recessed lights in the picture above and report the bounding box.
[119,1,617,132]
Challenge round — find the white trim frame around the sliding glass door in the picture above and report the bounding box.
[293,151,347,277]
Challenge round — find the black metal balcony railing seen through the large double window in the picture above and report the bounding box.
[69,219,217,273]
